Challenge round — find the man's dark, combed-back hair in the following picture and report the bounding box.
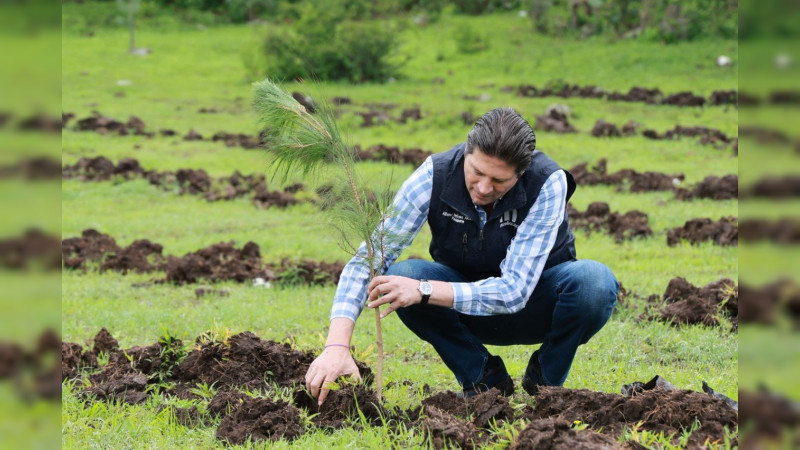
[466,107,536,174]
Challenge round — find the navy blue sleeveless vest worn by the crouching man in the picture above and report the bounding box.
[428,144,576,281]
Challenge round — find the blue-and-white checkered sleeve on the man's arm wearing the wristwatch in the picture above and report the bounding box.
[452,170,567,316]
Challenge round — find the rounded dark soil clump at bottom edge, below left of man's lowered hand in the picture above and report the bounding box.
[216,398,303,445]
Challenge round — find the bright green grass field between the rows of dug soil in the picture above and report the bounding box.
[59,4,739,448]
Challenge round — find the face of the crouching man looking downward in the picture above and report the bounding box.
[464,147,519,206]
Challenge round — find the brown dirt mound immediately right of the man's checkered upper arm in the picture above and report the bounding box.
[567,202,653,241]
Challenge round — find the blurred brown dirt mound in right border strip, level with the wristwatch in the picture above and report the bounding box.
[739,279,800,328]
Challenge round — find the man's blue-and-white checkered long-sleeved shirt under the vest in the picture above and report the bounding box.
[331,157,567,322]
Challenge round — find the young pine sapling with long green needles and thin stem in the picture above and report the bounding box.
[253,80,391,400]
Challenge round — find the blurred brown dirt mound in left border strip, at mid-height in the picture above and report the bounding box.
[0,229,61,270]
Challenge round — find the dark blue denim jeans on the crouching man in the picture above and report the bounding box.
[387,259,619,388]
